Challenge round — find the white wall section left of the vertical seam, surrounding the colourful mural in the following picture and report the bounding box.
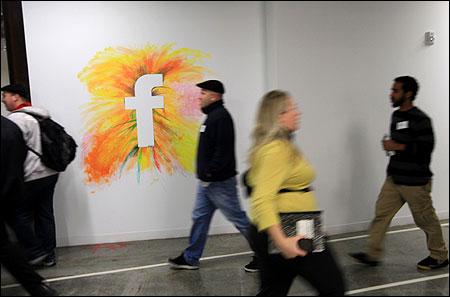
[23,1,263,245]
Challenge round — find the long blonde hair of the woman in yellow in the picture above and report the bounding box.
[248,90,300,164]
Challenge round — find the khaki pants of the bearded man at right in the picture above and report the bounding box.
[368,177,448,260]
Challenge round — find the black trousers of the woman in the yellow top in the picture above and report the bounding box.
[250,226,345,296]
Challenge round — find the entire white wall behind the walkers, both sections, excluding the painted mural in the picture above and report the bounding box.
[19,1,449,245]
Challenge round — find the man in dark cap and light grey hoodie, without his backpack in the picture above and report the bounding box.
[1,84,62,266]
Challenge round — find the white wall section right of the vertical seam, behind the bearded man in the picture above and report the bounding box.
[266,1,449,233]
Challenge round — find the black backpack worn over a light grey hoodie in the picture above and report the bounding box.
[16,111,77,172]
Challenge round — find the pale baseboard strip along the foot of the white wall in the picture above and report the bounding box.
[57,211,449,247]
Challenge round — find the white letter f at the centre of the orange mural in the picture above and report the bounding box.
[125,74,164,147]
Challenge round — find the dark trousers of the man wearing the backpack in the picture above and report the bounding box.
[14,174,58,260]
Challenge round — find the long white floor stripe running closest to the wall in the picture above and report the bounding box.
[1,223,449,294]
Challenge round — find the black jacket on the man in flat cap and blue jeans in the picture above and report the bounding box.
[197,100,237,182]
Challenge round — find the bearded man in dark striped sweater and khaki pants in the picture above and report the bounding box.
[350,76,448,270]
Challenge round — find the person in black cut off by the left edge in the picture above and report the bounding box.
[0,116,57,296]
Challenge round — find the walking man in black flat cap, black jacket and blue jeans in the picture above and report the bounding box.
[169,80,258,272]
